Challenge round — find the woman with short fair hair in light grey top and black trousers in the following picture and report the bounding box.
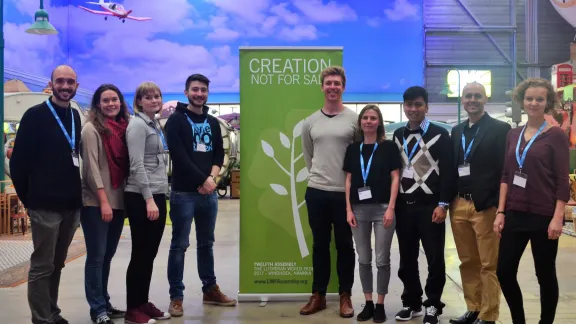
[124,82,170,324]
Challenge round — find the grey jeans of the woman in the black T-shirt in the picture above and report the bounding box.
[352,204,396,295]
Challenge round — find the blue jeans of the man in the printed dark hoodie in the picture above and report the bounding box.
[168,191,218,300]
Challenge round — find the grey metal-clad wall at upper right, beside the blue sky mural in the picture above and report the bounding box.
[424,0,575,103]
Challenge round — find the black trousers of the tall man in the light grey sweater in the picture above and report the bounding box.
[305,188,356,295]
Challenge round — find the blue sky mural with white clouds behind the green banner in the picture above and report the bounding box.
[4,0,423,100]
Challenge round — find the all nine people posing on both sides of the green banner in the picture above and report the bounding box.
[10,65,569,324]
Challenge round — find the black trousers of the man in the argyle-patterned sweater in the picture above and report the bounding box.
[396,201,446,313]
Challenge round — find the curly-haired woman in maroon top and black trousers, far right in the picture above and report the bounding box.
[494,79,570,324]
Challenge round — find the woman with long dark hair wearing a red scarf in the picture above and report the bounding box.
[80,84,130,324]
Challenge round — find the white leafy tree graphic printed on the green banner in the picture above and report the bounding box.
[262,120,310,258]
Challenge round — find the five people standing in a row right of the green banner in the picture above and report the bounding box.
[300,67,569,324]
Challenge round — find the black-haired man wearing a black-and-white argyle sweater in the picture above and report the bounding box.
[393,86,455,324]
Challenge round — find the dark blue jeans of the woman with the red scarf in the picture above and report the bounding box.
[80,207,124,319]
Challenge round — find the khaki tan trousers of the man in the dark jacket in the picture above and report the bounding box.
[450,197,500,321]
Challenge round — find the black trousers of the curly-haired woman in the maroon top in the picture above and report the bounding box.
[496,216,559,324]
